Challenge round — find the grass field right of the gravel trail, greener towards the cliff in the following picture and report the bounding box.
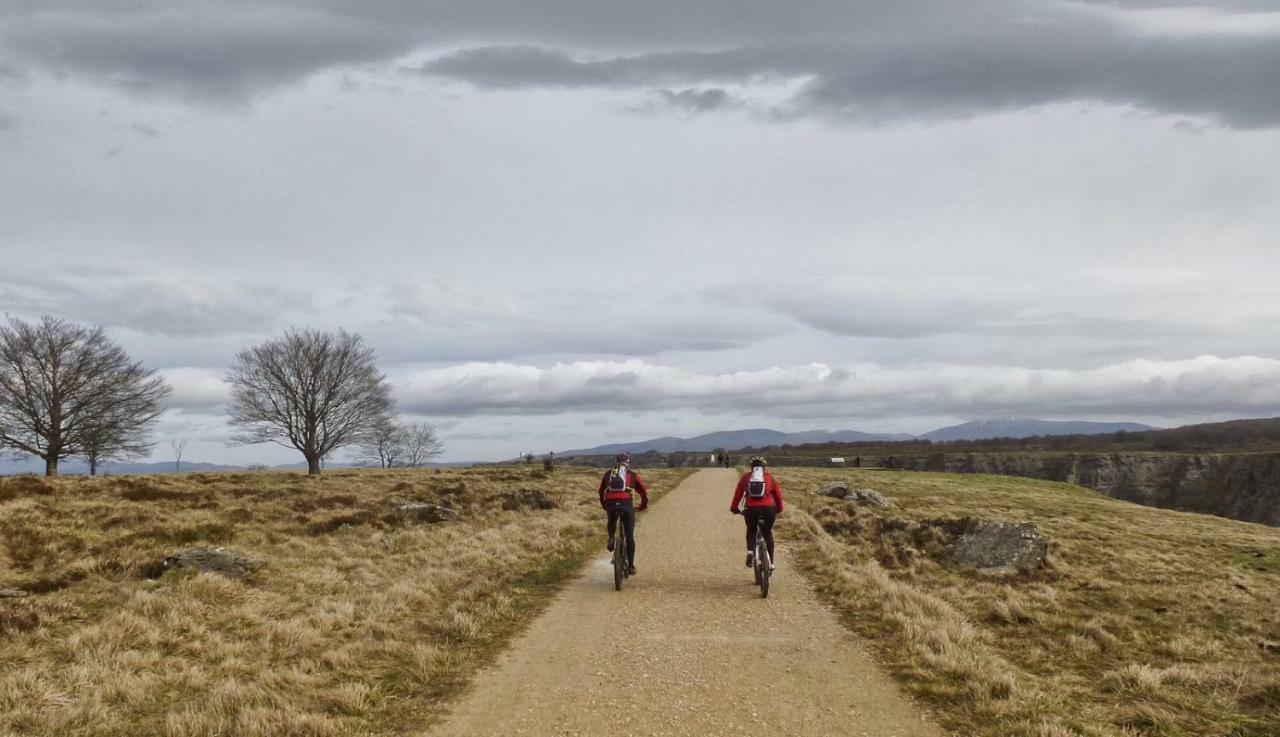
[777,468,1280,737]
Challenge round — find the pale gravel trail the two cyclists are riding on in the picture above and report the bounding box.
[431,470,941,737]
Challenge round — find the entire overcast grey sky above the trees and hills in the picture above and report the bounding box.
[0,0,1280,463]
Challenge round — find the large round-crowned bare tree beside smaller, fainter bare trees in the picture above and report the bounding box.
[227,329,392,475]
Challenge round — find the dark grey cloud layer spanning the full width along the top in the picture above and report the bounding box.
[0,0,1280,128]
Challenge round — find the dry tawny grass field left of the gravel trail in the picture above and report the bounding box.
[0,466,689,737]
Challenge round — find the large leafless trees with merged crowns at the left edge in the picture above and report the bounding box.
[0,316,172,476]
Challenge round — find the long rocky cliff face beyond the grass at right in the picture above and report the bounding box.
[868,452,1280,526]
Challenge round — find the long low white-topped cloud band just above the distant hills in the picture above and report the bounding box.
[392,356,1280,418]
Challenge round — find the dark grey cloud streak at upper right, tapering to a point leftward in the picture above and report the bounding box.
[421,18,1280,128]
